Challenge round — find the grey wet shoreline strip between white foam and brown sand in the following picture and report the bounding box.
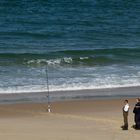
[0,86,140,104]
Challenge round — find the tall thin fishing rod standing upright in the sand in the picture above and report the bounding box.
[45,66,51,113]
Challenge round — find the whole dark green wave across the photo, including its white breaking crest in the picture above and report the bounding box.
[0,48,140,66]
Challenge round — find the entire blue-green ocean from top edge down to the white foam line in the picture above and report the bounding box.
[0,0,140,94]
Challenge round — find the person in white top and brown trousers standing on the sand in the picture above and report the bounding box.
[122,100,129,130]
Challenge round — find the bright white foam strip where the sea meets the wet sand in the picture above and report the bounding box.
[0,78,140,94]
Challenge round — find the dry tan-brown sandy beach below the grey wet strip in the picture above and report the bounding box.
[0,98,140,140]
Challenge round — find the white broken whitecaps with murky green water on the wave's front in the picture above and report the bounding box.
[24,57,117,66]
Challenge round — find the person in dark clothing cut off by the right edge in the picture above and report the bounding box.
[133,98,140,129]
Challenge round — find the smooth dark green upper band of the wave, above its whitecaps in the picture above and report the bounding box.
[0,48,140,58]
